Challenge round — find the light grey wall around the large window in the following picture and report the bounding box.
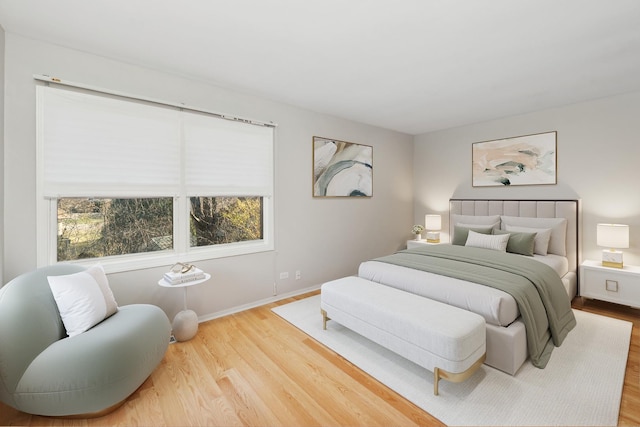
[4,33,413,318]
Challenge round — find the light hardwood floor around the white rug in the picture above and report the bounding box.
[0,292,640,426]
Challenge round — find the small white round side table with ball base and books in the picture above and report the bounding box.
[158,262,211,341]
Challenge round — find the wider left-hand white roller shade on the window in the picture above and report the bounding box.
[37,86,181,197]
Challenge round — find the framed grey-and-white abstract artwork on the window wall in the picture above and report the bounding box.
[313,136,373,197]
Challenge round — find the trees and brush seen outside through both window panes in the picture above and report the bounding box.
[57,197,263,261]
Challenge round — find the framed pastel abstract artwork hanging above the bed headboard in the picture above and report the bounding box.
[471,132,557,187]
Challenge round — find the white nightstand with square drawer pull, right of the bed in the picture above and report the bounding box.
[580,260,640,308]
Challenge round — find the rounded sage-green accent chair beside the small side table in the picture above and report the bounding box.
[0,264,171,417]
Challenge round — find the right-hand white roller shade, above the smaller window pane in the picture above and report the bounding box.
[183,112,273,196]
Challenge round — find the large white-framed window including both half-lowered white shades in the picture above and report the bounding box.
[37,86,274,271]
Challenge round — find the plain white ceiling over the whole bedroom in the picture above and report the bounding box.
[0,0,640,134]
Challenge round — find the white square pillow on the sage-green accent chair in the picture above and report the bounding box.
[47,265,118,337]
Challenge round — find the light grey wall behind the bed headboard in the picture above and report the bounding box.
[414,92,640,265]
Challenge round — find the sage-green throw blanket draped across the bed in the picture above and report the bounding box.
[375,245,576,368]
